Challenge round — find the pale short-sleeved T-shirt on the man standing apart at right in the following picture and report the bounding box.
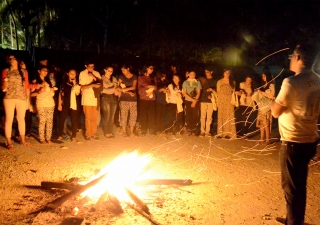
[275,71,320,143]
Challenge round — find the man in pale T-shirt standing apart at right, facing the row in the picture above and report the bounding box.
[271,44,320,225]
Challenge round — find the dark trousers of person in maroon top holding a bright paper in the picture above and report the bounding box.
[139,100,156,133]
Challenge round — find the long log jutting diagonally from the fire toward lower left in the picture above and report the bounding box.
[30,174,107,214]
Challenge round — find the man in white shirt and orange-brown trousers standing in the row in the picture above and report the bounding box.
[79,61,101,141]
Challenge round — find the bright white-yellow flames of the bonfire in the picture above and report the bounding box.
[81,151,151,201]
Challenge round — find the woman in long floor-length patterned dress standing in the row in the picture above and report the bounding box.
[217,69,236,139]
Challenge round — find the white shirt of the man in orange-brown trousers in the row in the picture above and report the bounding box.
[79,69,101,106]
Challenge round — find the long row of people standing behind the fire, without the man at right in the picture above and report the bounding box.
[2,55,274,149]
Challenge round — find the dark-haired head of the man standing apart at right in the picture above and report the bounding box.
[289,43,319,73]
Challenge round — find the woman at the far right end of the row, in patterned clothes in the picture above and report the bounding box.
[255,69,275,145]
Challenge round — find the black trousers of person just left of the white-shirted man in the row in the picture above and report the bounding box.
[58,105,81,138]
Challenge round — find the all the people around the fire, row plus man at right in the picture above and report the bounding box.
[2,41,320,225]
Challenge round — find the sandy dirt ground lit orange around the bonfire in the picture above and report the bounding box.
[0,125,320,225]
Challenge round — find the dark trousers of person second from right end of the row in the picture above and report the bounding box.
[236,105,256,136]
